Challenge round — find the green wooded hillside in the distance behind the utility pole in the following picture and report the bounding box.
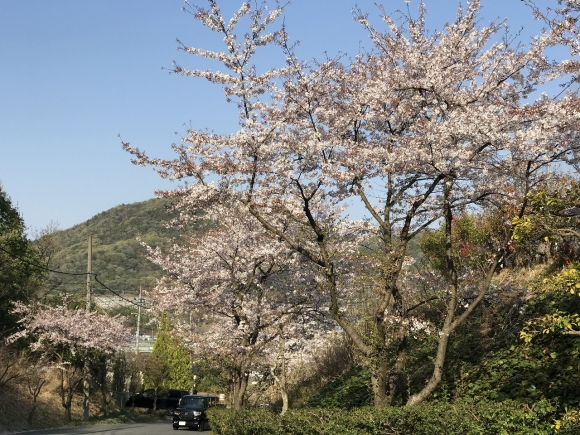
[50,199,184,295]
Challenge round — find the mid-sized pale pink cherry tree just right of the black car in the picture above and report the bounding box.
[143,204,324,409]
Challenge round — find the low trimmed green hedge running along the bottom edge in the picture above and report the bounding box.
[209,400,554,435]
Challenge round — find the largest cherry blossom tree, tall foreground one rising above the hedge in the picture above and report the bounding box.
[124,0,580,406]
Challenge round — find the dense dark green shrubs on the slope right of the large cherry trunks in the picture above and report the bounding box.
[412,271,580,412]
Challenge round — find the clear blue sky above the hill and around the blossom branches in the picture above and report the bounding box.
[0,0,544,235]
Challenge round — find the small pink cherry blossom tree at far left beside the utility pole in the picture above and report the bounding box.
[8,300,131,421]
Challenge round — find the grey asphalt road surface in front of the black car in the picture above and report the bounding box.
[12,421,210,435]
